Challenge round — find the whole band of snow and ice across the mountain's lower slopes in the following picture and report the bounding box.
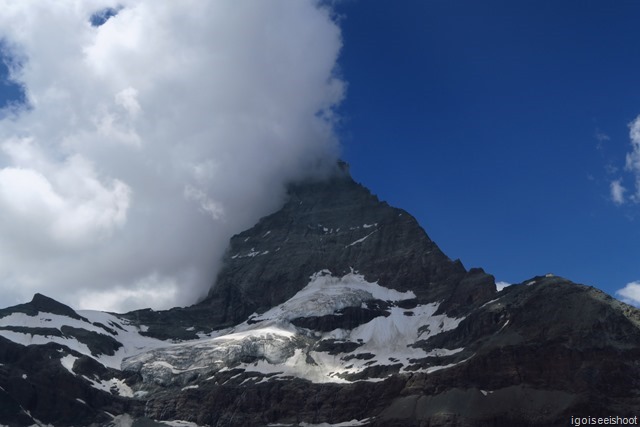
[0,270,470,396]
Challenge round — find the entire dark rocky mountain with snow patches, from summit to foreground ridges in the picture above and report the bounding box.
[0,164,640,426]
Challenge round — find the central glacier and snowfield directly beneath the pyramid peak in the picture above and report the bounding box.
[123,270,462,383]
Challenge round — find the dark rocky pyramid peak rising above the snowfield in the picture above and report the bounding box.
[200,171,495,324]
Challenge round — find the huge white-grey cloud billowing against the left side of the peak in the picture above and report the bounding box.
[0,0,344,310]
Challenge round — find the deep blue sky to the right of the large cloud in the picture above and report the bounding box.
[337,0,640,300]
